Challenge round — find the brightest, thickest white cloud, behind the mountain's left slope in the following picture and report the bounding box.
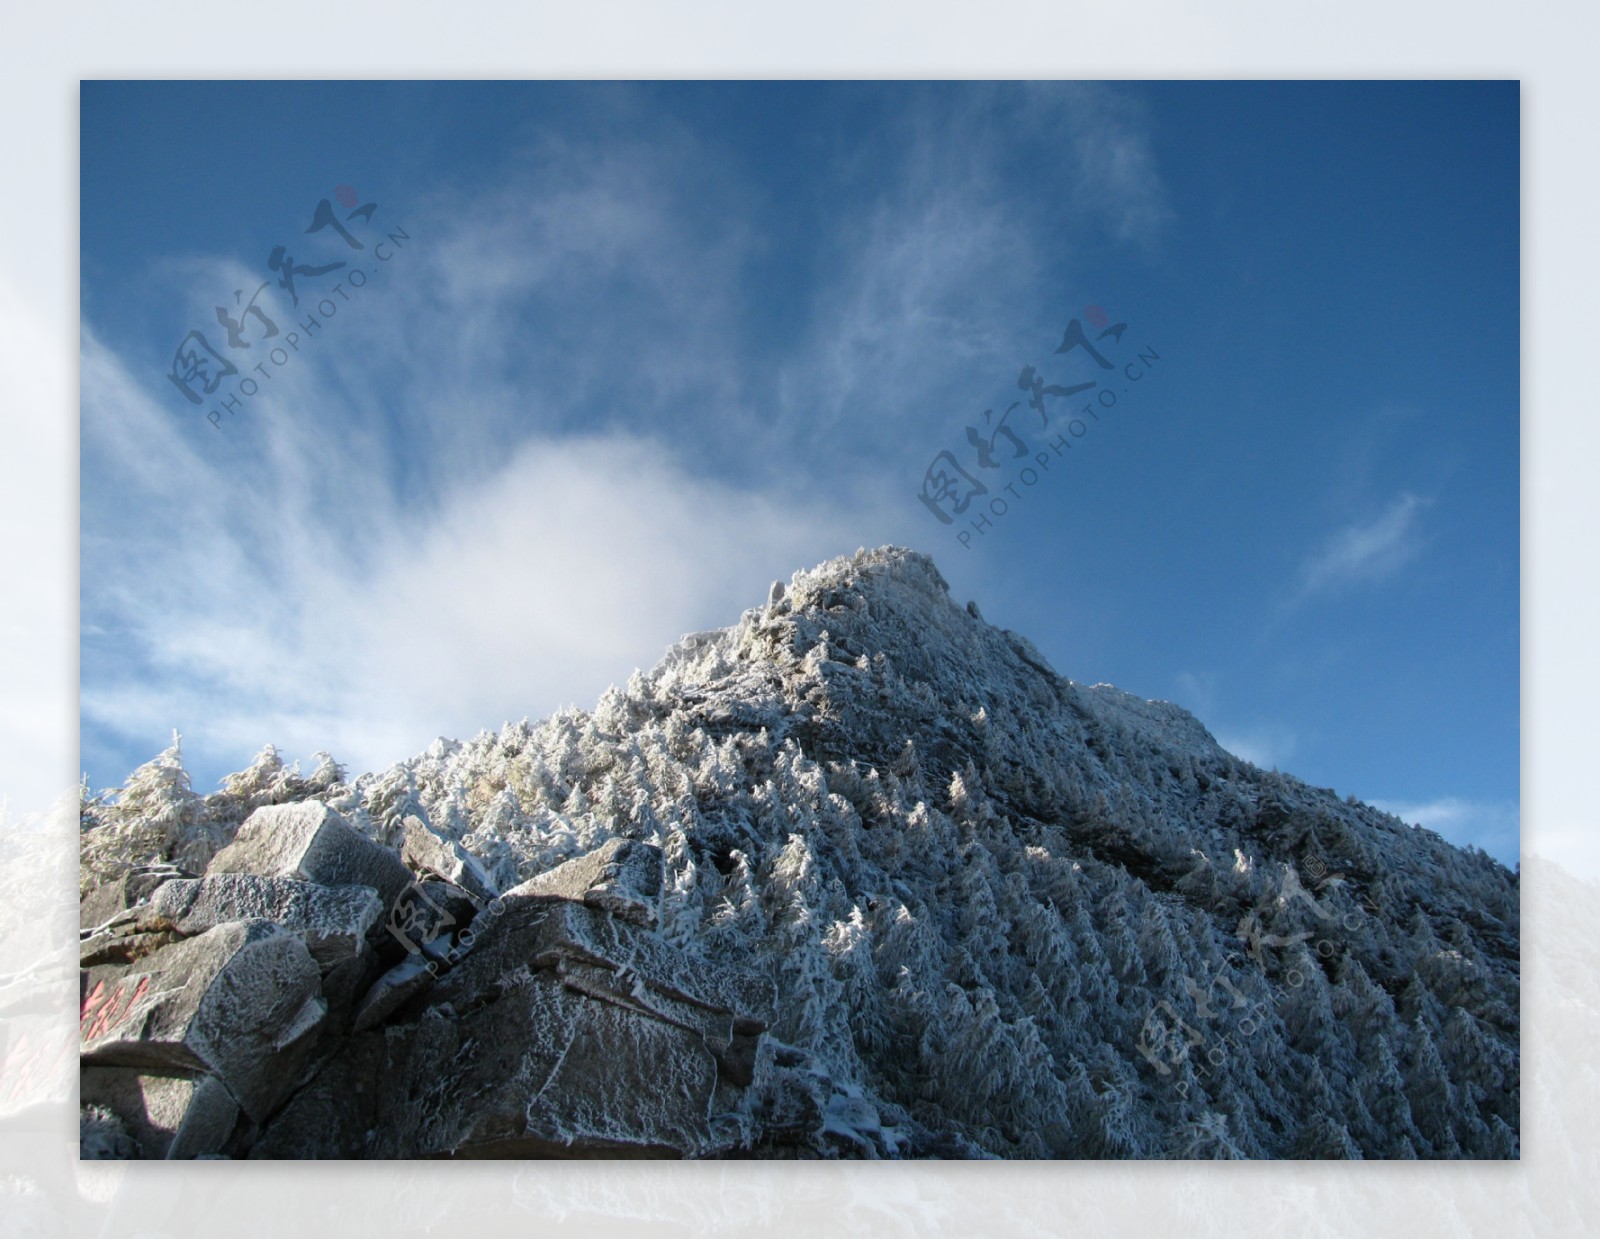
[82,320,870,787]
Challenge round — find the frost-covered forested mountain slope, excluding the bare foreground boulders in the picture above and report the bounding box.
[85,547,1518,1158]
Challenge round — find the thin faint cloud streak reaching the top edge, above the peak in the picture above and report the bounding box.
[768,83,1171,470]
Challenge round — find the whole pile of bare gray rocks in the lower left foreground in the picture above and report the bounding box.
[80,816,800,1158]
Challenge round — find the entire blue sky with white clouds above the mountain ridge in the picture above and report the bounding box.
[80,82,1520,861]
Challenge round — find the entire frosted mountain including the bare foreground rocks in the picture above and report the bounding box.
[80,547,1520,1158]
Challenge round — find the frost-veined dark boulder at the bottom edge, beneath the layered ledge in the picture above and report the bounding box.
[259,974,739,1158]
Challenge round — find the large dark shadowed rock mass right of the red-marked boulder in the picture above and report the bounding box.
[251,896,771,1157]
